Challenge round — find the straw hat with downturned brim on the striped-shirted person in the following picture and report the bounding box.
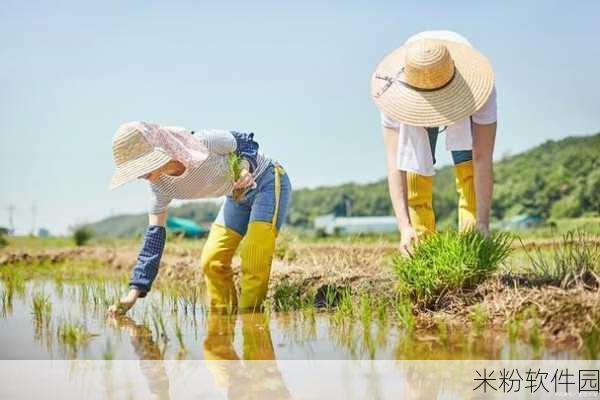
[110,123,171,190]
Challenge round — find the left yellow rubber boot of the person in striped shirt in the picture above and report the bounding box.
[200,224,242,311]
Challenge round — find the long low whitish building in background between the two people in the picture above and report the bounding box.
[314,214,398,235]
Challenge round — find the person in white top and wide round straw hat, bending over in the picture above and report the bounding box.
[371,31,497,254]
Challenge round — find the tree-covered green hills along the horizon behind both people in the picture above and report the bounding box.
[91,133,600,237]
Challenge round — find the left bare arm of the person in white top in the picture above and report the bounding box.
[382,127,417,253]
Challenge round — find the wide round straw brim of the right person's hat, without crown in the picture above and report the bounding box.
[371,40,494,127]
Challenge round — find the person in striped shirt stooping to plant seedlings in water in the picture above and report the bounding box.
[108,121,291,316]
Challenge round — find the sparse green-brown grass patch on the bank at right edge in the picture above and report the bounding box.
[521,231,600,289]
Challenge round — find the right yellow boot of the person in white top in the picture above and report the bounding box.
[454,161,477,232]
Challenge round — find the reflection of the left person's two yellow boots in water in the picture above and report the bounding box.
[204,313,290,399]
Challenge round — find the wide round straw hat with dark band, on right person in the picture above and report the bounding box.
[371,39,494,127]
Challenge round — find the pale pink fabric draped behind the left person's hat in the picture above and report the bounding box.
[131,121,209,168]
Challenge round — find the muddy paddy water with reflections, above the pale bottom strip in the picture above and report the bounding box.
[0,280,577,360]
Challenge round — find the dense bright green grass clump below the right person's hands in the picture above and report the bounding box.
[393,231,512,305]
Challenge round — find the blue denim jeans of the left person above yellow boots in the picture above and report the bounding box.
[215,164,292,236]
